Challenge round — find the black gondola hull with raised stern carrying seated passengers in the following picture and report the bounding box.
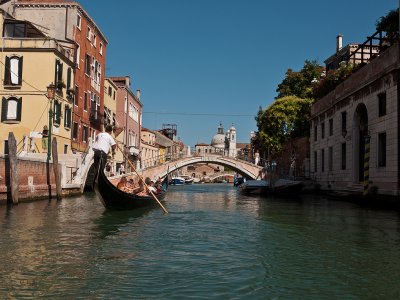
[94,160,167,210]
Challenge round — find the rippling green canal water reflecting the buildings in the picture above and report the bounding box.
[0,184,400,299]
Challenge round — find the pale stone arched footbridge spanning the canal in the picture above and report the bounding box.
[142,154,262,179]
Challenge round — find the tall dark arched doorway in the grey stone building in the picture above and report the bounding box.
[353,104,368,182]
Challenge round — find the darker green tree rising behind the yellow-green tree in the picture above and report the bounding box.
[276,60,324,99]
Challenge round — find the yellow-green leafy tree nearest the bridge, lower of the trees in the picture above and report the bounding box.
[256,96,312,152]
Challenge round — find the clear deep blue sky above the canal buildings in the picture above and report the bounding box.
[79,0,399,146]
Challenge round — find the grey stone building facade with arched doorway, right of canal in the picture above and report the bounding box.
[310,43,400,195]
